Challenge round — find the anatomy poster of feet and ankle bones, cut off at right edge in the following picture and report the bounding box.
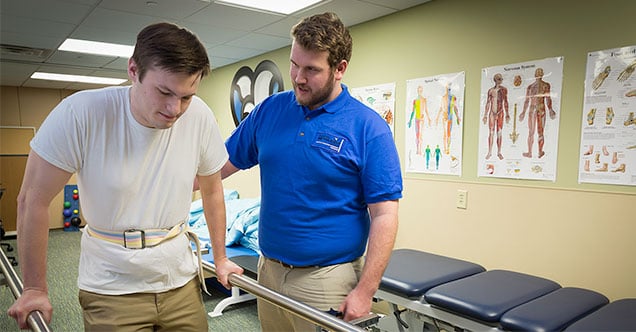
[579,46,636,186]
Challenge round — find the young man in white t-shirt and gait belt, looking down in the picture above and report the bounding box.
[8,23,242,331]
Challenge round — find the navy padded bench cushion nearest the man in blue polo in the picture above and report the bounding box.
[380,249,485,298]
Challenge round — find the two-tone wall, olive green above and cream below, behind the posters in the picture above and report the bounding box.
[200,0,636,299]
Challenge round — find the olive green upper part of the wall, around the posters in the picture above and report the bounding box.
[201,0,636,193]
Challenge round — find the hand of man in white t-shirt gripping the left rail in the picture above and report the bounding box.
[7,288,53,330]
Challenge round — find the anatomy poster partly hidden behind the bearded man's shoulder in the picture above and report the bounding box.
[350,83,395,136]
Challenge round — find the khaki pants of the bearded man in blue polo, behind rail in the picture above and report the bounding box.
[257,256,362,332]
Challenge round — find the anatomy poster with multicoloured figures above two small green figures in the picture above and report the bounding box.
[405,72,466,176]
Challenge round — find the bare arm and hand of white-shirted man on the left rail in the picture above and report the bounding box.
[8,151,72,329]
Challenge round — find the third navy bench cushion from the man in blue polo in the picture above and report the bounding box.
[500,287,609,332]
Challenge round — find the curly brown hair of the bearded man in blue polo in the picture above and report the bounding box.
[291,12,353,68]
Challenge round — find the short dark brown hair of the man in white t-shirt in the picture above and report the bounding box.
[132,22,210,81]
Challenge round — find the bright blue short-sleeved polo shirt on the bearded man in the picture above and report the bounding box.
[226,85,402,266]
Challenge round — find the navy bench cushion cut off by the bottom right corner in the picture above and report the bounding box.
[565,299,636,331]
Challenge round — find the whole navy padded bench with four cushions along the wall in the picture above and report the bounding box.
[376,249,636,332]
